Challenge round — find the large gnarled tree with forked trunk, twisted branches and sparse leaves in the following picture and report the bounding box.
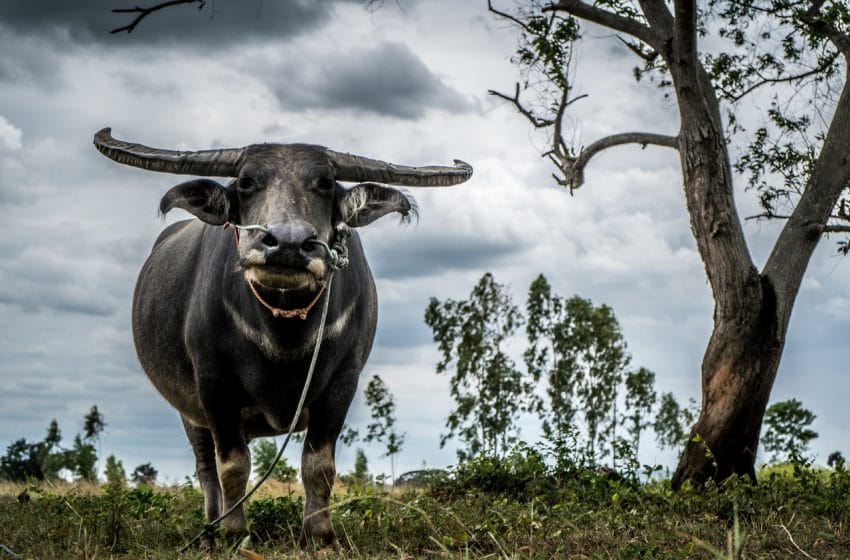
[488,0,850,487]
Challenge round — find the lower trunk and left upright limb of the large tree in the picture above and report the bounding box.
[662,0,787,488]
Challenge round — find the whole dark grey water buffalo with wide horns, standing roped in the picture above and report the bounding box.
[94,128,472,545]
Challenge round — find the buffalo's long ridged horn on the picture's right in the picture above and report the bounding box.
[327,150,472,187]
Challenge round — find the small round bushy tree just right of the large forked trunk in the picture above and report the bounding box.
[761,399,818,462]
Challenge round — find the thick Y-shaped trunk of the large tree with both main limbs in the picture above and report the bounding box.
[664,0,850,488]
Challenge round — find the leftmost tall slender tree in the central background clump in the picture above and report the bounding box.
[425,272,533,460]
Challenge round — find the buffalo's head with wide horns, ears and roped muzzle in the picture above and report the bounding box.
[94,128,472,291]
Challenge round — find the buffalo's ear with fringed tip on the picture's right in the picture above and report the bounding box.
[337,183,416,227]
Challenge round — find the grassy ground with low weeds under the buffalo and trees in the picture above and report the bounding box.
[0,453,850,560]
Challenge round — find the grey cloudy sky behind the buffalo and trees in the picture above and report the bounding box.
[0,0,850,482]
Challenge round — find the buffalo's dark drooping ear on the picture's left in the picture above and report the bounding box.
[159,179,236,226]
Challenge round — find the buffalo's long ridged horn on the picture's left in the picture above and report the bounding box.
[94,128,245,177]
